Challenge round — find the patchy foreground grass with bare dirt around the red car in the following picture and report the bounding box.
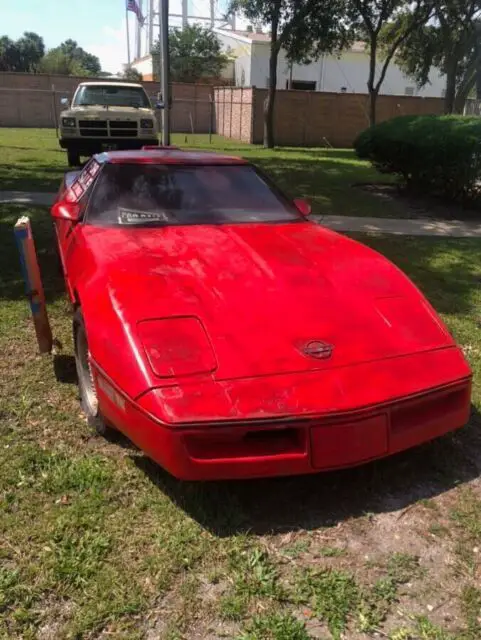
[0,198,481,640]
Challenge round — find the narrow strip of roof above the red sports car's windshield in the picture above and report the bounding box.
[95,147,248,165]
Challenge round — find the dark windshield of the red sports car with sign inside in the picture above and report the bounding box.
[87,164,301,226]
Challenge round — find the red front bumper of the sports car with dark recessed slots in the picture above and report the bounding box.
[95,350,471,480]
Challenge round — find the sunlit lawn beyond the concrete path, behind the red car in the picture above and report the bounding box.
[0,129,404,217]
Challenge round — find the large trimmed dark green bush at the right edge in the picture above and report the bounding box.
[354,116,481,201]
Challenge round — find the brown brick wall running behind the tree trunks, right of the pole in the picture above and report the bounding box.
[214,88,443,147]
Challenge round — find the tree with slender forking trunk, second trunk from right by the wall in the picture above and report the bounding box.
[349,0,433,126]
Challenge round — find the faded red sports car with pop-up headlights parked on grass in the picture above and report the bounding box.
[52,149,471,480]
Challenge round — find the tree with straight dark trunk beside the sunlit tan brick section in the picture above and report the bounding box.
[230,0,349,148]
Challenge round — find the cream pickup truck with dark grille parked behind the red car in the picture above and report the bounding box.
[59,82,158,167]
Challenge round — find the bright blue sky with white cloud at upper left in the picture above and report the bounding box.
[0,0,232,73]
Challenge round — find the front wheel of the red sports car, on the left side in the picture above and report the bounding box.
[73,309,110,436]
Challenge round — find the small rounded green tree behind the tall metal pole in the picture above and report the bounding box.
[152,24,230,82]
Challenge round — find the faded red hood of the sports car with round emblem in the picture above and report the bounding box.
[80,222,453,380]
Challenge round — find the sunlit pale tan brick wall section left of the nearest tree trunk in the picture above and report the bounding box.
[214,87,255,142]
